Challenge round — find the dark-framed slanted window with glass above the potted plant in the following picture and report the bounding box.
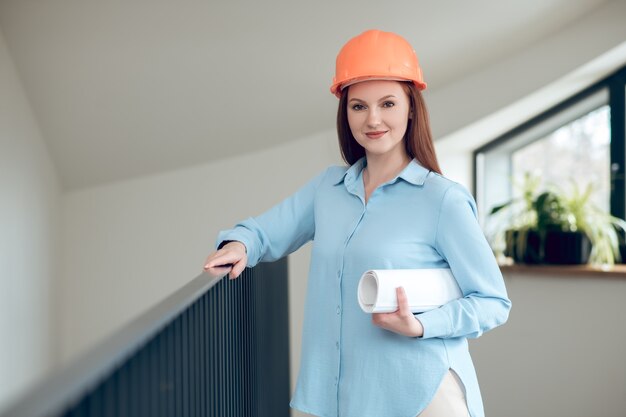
[474,68,626,252]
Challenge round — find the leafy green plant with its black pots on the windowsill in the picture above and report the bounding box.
[490,173,626,266]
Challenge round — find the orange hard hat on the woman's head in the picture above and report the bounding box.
[330,30,426,97]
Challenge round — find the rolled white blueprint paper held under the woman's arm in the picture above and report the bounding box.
[358,268,463,313]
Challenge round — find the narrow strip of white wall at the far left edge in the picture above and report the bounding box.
[0,30,59,408]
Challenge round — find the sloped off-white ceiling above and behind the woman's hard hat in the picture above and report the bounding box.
[0,0,606,189]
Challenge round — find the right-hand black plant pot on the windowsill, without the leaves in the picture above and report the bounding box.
[544,230,591,265]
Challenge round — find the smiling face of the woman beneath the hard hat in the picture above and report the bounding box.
[347,80,410,157]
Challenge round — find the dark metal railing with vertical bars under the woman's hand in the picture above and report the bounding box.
[0,258,289,417]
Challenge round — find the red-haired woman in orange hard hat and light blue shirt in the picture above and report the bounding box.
[205,30,511,417]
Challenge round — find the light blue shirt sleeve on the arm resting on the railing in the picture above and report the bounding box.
[215,170,327,267]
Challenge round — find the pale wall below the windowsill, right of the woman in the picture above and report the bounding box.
[470,273,626,417]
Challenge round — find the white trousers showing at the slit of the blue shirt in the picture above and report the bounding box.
[417,370,469,417]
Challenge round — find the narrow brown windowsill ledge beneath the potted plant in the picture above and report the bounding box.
[500,264,626,278]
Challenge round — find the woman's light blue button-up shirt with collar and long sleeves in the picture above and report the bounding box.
[216,157,511,417]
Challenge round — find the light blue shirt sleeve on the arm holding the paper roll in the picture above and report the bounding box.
[417,184,511,338]
